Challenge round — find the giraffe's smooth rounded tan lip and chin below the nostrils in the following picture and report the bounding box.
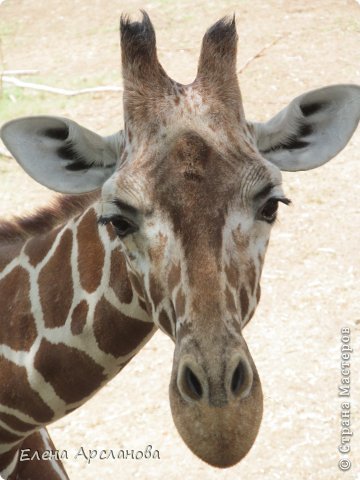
[169,361,263,468]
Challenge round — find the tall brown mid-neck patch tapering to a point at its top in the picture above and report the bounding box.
[39,230,74,328]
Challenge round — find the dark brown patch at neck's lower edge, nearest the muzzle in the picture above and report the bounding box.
[93,297,154,357]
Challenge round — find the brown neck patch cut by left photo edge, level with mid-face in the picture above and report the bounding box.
[0,267,37,348]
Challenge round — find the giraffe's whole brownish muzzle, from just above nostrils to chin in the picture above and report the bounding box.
[169,336,263,468]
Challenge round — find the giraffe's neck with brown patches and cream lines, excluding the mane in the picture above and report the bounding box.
[0,205,155,455]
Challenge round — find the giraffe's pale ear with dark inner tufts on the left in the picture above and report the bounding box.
[0,116,123,194]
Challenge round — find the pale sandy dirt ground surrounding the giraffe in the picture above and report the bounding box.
[0,0,360,480]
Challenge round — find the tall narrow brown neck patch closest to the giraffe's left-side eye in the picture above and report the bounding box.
[77,209,105,293]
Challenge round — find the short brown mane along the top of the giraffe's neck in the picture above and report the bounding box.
[0,190,100,245]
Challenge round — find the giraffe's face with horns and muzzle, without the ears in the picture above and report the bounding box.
[98,15,270,466]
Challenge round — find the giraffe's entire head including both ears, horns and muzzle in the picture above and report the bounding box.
[2,13,360,467]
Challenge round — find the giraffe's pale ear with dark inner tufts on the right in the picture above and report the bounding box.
[253,85,360,172]
